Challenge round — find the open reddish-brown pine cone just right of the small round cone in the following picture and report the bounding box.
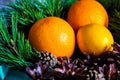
[54,57,85,80]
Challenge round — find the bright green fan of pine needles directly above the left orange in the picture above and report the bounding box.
[39,0,63,17]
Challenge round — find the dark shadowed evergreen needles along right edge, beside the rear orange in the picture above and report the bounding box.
[99,0,120,43]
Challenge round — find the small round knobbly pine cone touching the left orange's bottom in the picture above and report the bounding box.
[39,52,57,67]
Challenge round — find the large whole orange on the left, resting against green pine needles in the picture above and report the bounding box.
[28,17,75,57]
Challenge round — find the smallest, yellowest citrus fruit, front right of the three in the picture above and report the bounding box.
[77,24,114,56]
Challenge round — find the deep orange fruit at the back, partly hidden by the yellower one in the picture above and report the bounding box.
[67,0,108,32]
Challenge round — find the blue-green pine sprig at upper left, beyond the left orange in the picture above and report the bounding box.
[5,0,45,26]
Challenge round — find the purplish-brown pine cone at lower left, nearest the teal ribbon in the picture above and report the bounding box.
[26,62,54,80]
